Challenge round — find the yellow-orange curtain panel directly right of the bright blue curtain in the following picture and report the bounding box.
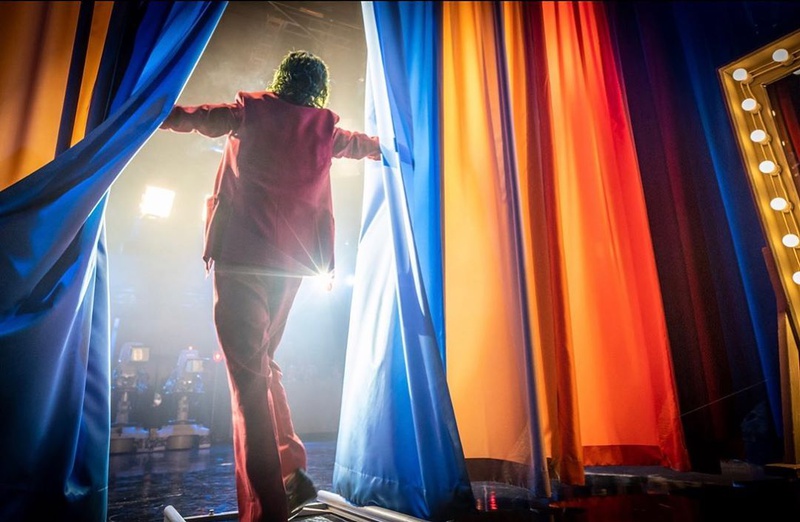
[442,2,544,484]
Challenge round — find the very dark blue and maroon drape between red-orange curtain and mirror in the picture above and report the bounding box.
[608,2,800,471]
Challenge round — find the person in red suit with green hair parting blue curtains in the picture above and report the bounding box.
[161,51,380,522]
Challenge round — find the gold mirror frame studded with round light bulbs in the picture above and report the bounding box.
[719,30,800,467]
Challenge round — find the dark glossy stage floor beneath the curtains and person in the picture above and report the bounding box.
[108,439,800,522]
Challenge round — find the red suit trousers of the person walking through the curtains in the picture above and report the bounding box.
[214,267,306,522]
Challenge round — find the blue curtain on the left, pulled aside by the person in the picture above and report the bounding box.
[0,2,226,521]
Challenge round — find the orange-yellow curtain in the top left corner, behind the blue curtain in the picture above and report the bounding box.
[0,2,113,190]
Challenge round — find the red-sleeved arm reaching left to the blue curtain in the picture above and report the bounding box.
[159,103,242,138]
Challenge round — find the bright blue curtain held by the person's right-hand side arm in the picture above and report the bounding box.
[333,2,474,520]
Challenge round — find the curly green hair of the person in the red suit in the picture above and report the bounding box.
[268,51,329,109]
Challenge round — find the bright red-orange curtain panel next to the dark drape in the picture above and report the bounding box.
[541,2,689,469]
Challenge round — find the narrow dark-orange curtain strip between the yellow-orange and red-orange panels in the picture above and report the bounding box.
[503,2,585,484]
